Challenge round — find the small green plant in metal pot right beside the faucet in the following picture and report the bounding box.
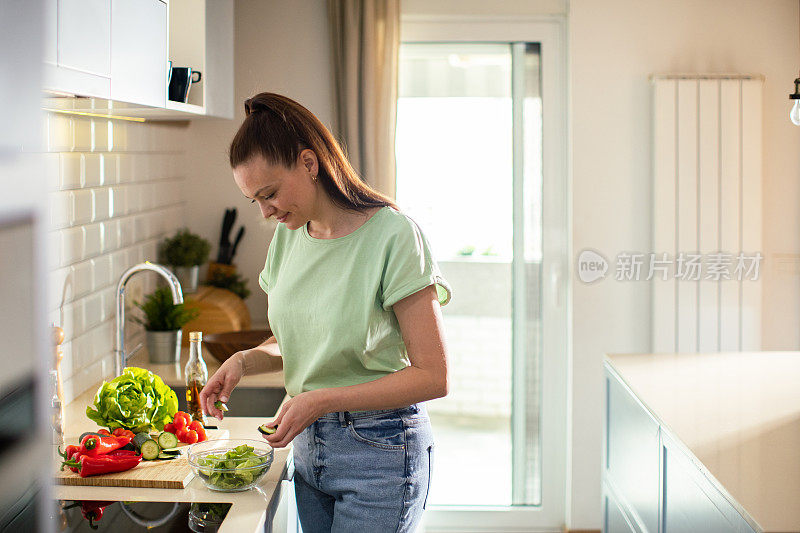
[134,287,198,363]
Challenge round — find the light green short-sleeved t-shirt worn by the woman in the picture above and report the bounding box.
[258,207,451,396]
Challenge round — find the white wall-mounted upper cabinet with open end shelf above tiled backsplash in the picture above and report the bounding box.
[41,0,233,120]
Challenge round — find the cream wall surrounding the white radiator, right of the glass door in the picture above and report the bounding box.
[569,0,800,529]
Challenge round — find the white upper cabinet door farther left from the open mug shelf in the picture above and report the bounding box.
[58,0,111,78]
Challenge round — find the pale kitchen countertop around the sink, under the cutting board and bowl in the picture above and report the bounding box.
[53,349,292,533]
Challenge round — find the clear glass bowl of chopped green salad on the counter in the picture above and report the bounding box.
[187,439,274,492]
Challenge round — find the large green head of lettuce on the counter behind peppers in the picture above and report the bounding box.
[86,366,178,432]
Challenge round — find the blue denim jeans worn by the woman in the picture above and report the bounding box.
[292,404,433,533]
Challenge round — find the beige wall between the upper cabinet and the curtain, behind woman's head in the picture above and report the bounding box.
[186,0,333,326]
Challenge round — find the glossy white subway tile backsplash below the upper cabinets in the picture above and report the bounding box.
[49,113,186,401]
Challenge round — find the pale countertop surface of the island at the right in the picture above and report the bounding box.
[607,352,800,532]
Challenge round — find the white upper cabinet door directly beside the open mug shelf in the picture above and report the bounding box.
[111,0,167,107]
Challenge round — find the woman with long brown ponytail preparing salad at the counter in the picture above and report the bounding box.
[200,93,450,533]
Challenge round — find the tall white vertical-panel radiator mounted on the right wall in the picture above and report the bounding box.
[650,75,763,352]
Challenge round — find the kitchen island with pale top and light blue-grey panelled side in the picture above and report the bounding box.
[603,352,800,533]
